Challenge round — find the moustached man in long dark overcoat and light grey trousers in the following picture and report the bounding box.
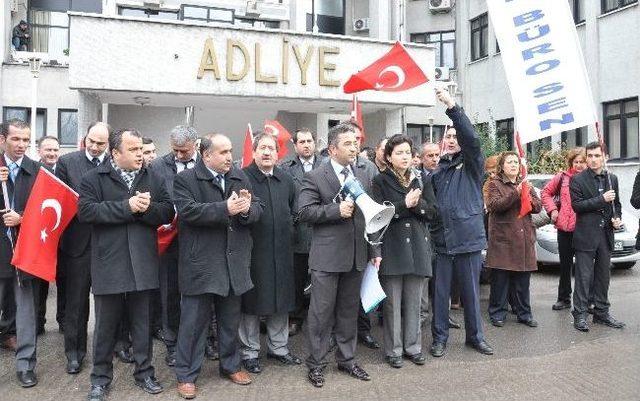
[239,133,302,373]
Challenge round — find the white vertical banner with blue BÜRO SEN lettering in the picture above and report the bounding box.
[487,0,596,143]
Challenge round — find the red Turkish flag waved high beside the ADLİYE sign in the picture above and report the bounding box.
[342,42,428,93]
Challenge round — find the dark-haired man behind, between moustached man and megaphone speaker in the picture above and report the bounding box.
[280,128,324,336]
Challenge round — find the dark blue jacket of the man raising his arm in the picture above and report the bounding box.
[432,105,487,255]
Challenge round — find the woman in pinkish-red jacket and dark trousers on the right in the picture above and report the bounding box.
[540,147,587,310]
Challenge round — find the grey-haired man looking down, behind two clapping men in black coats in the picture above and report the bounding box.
[151,125,198,366]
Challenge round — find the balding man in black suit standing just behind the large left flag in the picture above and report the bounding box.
[56,122,111,374]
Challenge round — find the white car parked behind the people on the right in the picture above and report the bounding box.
[527,174,640,269]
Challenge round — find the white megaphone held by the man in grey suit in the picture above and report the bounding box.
[339,175,396,245]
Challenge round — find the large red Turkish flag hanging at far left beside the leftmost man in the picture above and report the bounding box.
[11,167,78,281]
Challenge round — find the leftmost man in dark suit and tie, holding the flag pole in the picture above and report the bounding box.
[0,120,40,387]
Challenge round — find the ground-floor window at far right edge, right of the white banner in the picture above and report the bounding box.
[603,98,640,159]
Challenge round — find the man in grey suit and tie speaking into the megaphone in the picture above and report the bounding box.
[298,124,381,387]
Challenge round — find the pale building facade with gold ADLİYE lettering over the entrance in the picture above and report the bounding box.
[0,0,640,211]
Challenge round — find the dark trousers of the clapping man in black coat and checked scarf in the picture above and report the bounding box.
[91,291,154,386]
